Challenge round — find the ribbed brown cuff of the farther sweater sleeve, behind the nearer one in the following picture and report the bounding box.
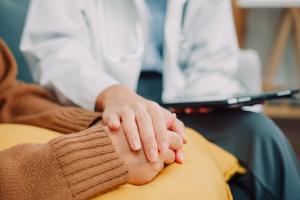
[49,107,101,133]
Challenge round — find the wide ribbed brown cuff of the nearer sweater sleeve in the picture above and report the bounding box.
[49,126,129,199]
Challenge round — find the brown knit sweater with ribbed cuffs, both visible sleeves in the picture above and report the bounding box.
[0,39,129,200]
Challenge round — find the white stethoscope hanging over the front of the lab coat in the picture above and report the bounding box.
[98,0,188,65]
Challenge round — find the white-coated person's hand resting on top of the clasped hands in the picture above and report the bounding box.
[96,85,185,163]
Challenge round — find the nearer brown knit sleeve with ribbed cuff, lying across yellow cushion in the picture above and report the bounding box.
[0,126,129,200]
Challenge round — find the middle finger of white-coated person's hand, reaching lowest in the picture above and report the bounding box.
[134,106,158,162]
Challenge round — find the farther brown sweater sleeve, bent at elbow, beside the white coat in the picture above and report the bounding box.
[0,39,101,133]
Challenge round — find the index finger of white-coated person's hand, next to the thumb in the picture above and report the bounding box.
[121,108,142,151]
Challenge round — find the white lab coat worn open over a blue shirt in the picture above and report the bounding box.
[21,0,241,110]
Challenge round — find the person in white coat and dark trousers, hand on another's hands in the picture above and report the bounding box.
[21,0,300,199]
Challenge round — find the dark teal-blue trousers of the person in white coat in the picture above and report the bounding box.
[138,73,300,200]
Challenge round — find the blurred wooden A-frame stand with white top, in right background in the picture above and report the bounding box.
[237,0,300,90]
